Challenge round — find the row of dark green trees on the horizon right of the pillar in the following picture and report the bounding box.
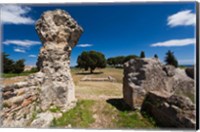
[77,50,178,73]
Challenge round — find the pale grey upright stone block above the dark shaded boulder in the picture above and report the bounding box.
[123,58,195,109]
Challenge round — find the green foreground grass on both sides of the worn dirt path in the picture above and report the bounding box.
[51,100,156,129]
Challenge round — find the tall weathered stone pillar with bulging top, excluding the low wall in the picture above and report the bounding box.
[36,10,83,110]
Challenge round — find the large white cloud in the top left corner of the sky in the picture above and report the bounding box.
[0,5,35,24]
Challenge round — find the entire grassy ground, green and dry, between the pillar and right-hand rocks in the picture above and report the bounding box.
[2,68,156,129]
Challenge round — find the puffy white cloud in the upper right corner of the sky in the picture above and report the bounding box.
[167,10,196,27]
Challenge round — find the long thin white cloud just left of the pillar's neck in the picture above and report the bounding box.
[3,40,41,47]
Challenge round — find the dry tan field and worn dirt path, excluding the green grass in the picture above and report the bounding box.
[3,68,155,128]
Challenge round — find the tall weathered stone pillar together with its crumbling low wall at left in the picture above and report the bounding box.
[0,9,83,127]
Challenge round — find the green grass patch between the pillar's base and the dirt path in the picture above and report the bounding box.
[51,100,94,128]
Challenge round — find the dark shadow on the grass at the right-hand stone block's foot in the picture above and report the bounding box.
[106,98,132,111]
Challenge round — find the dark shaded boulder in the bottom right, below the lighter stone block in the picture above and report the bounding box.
[141,91,196,129]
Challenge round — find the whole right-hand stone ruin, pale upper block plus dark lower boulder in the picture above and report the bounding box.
[123,58,195,128]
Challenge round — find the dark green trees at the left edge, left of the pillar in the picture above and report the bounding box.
[2,52,25,74]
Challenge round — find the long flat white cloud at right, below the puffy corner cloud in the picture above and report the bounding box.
[151,38,195,47]
